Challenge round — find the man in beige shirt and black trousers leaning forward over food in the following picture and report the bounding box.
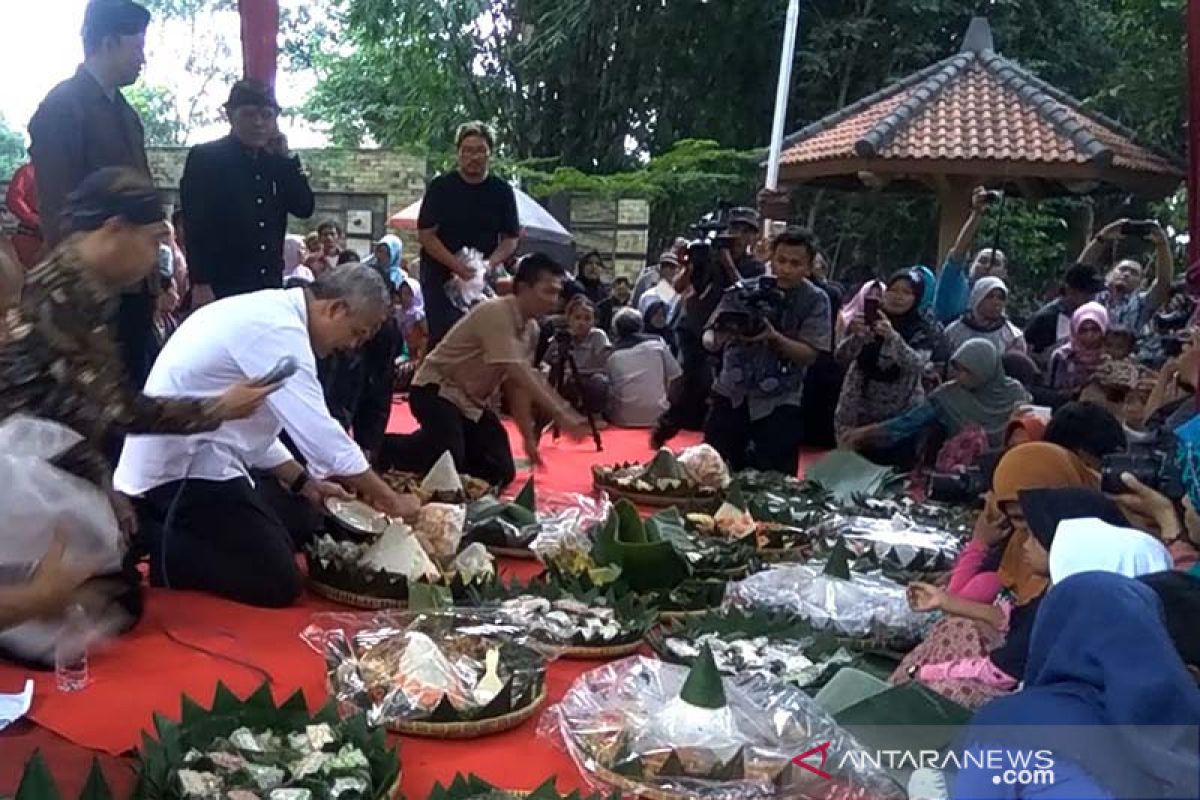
[378,253,589,486]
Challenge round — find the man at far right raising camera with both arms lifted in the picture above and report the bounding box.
[1079,219,1175,335]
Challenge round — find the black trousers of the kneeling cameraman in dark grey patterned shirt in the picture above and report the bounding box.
[704,395,803,475]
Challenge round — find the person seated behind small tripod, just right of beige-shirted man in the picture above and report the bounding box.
[546,295,612,415]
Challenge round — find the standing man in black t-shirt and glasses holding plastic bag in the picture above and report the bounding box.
[416,122,521,349]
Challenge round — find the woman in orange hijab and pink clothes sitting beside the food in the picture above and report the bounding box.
[892,443,1104,708]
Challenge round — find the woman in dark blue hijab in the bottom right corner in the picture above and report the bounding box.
[950,572,1200,800]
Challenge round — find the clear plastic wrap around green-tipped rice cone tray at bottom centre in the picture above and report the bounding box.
[539,656,905,800]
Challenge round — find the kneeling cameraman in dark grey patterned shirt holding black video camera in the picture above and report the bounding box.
[703,228,832,475]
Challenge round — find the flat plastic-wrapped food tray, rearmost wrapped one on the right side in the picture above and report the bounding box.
[810,515,962,572]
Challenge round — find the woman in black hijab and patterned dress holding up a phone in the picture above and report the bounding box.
[834,270,948,467]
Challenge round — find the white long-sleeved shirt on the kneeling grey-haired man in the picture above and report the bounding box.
[113,289,370,495]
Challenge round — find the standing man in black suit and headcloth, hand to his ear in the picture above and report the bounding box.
[179,80,314,307]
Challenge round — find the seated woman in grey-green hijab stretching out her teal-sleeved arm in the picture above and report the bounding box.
[841,339,1030,462]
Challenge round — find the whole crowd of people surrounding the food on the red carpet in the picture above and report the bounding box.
[0,0,1200,800]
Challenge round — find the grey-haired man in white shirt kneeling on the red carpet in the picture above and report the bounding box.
[115,264,419,607]
